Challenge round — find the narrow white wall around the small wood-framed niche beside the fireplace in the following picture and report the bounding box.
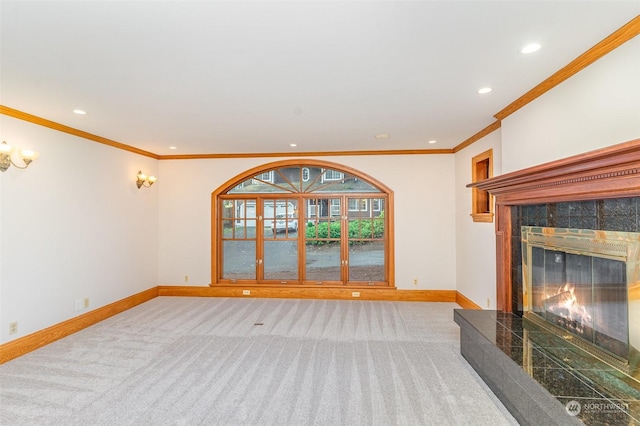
[455,130,502,309]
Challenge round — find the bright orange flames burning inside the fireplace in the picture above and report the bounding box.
[544,283,593,334]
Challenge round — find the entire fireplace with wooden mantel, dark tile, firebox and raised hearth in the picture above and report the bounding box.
[457,139,640,425]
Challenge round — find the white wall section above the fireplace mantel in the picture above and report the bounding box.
[502,37,640,173]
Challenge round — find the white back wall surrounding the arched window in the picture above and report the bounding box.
[159,155,456,290]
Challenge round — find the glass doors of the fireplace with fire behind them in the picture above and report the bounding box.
[531,247,629,358]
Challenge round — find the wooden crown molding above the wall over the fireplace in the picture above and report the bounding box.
[494,16,640,120]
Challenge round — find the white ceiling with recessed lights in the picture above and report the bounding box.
[0,0,640,155]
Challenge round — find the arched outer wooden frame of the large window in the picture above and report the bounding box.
[210,159,395,289]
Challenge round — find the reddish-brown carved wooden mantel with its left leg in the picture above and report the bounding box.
[467,139,640,312]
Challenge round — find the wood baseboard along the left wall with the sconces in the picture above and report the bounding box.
[0,287,158,364]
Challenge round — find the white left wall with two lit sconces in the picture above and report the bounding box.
[0,116,161,342]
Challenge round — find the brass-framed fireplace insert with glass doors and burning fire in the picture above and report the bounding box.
[521,226,640,376]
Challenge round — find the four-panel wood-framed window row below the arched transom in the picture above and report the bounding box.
[219,194,388,286]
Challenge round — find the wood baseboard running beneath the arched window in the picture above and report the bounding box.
[158,285,457,302]
